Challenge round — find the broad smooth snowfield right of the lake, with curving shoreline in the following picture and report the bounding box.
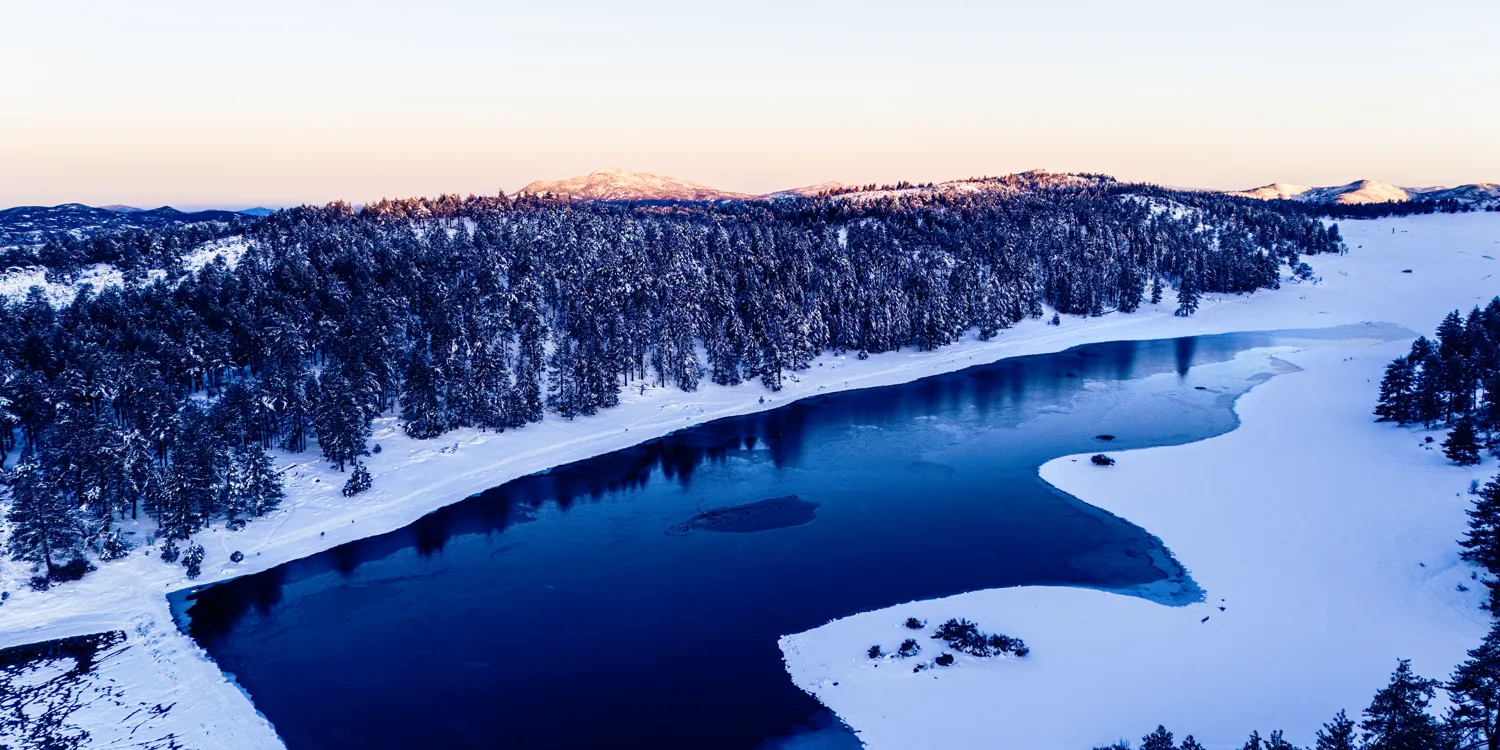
[782,215,1500,750]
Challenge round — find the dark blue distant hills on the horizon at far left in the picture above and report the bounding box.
[0,203,257,248]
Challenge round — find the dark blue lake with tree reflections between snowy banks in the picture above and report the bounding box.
[174,332,1386,750]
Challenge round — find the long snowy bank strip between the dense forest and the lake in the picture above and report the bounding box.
[0,215,1500,749]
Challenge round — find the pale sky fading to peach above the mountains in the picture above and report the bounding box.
[0,0,1500,207]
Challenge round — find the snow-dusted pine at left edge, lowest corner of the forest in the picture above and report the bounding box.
[6,458,84,579]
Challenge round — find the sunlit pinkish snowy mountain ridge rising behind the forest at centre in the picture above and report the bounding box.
[521,168,1113,201]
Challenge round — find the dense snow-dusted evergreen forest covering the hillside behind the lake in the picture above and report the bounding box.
[0,180,1344,587]
